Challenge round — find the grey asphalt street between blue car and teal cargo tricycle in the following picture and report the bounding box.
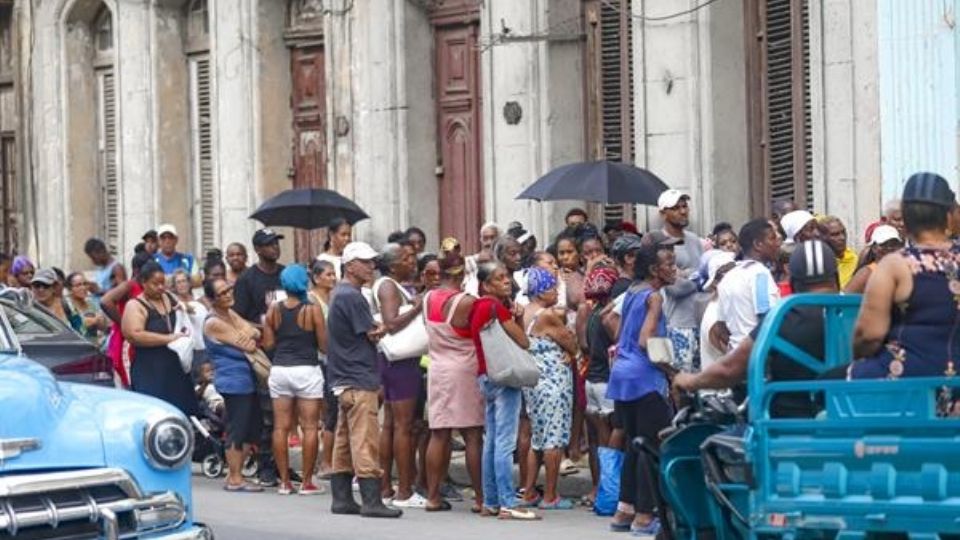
[193,476,652,540]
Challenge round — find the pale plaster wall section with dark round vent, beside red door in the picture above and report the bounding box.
[478,0,585,246]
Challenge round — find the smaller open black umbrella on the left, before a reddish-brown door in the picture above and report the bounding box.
[250,188,370,230]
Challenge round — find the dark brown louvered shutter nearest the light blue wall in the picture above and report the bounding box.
[759,0,813,211]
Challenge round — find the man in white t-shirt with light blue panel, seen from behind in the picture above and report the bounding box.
[710,218,780,350]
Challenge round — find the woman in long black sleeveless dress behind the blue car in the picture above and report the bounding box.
[122,261,199,416]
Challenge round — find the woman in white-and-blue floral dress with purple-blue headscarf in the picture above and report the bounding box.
[523,267,578,510]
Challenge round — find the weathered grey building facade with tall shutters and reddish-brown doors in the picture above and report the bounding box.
[0,0,957,267]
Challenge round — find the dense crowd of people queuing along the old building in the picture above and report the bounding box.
[7,173,960,534]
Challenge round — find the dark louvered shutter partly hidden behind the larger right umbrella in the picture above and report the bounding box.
[597,0,634,222]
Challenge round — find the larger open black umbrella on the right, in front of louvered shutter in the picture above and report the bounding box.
[517,161,669,205]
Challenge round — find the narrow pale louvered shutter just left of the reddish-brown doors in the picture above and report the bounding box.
[190,55,217,253]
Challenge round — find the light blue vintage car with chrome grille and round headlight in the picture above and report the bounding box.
[0,306,213,539]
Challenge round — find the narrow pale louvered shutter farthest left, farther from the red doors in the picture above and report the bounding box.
[97,69,120,255]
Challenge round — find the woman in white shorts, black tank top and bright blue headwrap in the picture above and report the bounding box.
[263,265,327,495]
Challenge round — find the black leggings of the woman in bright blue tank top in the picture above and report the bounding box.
[614,392,673,514]
